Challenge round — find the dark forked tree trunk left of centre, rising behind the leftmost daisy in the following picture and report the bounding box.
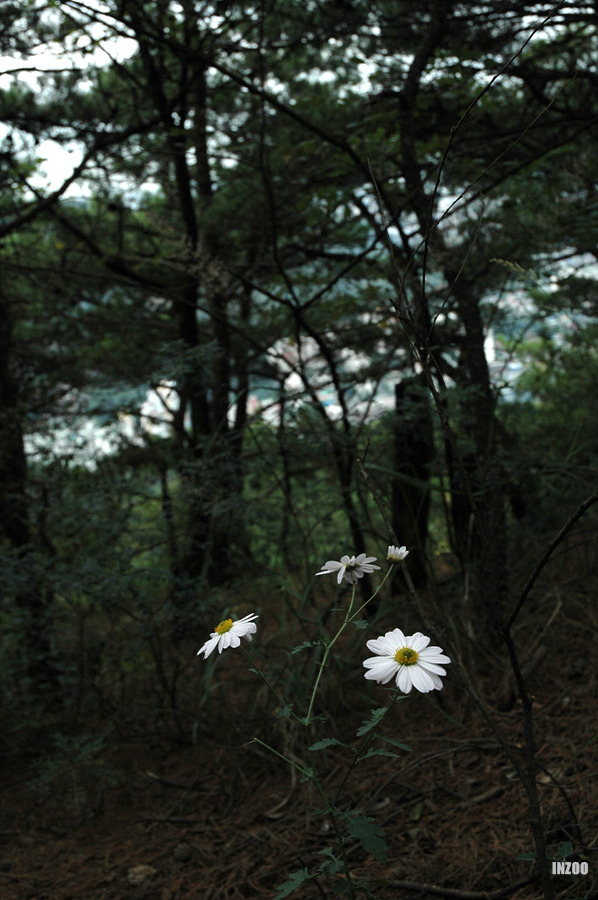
[127,12,248,592]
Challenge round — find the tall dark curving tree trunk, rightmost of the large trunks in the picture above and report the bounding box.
[398,0,506,643]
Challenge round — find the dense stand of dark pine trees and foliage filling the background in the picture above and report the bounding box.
[0,0,598,696]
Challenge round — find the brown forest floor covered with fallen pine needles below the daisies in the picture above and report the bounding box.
[0,560,598,900]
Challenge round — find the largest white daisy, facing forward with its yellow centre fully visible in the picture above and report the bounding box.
[363,628,450,694]
